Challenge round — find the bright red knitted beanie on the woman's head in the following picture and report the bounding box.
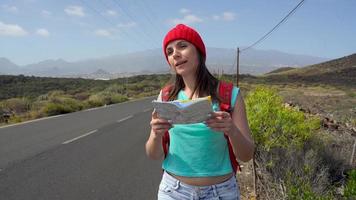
[163,24,206,61]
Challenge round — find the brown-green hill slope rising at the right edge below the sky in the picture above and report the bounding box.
[264,54,356,86]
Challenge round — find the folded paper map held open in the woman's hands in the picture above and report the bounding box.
[152,96,213,124]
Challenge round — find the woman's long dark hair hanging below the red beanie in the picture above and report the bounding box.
[167,49,220,102]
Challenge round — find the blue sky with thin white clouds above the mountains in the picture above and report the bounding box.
[0,0,356,65]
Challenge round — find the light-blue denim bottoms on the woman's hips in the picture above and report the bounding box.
[158,172,240,200]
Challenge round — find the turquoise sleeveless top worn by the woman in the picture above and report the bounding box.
[162,87,239,177]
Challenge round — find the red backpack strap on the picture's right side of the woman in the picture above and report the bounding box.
[219,81,241,173]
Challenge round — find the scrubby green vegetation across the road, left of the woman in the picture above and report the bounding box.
[0,75,169,125]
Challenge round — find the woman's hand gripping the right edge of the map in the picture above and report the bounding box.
[205,111,235,136]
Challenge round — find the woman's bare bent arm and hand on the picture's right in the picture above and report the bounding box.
[207,94,255,162]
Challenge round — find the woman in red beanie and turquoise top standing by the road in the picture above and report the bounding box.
[146,24,254,200]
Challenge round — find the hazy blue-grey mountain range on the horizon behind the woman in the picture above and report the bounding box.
[0,48,329,79]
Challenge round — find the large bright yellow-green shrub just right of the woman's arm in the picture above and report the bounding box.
[246,87,320,151]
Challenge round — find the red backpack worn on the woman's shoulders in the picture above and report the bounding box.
[162,81,241,173]
